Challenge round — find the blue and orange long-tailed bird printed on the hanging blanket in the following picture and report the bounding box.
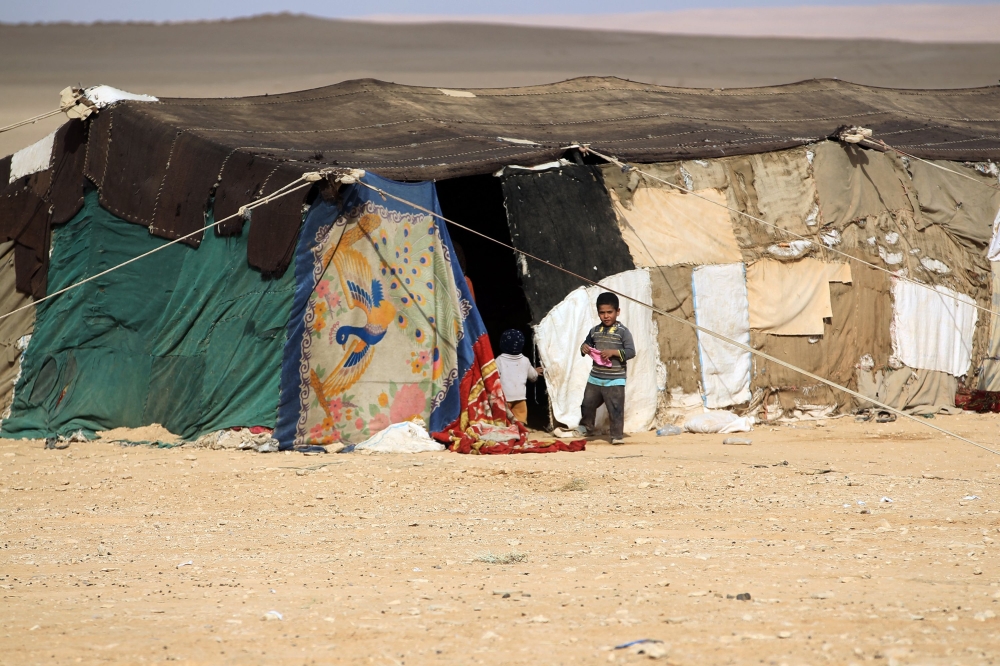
[309,214,396,416]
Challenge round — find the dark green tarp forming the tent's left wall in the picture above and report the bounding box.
[2,192,295,439]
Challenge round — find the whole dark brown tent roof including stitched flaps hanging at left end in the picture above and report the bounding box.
[0,77,1000,290]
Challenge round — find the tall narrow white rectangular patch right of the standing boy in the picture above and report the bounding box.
[691,264,750,409]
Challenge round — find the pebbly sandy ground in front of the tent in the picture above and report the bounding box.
[0,415,1000,665]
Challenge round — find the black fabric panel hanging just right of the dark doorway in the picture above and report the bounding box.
[502,166,635,324]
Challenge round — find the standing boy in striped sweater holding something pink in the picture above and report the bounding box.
[577,291,635,445]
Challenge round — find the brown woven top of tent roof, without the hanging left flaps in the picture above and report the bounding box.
[115,77,1000,180]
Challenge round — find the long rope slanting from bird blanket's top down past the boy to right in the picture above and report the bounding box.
[356,180,1000,455]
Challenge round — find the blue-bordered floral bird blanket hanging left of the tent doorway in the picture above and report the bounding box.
[275,174,506,447]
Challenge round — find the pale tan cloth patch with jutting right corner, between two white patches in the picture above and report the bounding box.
[747,259,851,335]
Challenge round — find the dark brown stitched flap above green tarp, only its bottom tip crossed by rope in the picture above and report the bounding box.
[149,133,230,247]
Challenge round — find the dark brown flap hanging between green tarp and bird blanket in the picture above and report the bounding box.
[247,165,310,277]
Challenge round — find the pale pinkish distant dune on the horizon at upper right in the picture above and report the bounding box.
[368,4,1000,42]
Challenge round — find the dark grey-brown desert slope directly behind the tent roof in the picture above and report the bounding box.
[0,12,1000,155]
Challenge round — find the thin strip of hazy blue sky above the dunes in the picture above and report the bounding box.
[0,0,1000,23]
